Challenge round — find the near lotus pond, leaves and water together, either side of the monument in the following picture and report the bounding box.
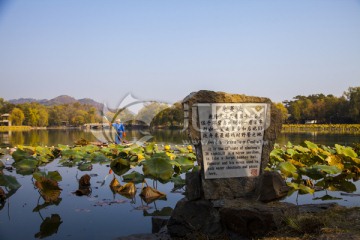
[0,130,360,239]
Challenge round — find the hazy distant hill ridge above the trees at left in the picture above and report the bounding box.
[9,95,103,110]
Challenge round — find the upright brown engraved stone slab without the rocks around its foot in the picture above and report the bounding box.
[182,90,282,200]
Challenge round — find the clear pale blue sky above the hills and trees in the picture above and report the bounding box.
[0,0,360,106]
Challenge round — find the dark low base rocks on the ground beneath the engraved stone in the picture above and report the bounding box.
[167,198,298,239]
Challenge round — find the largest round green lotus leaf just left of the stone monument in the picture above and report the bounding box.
[142,153,174,181]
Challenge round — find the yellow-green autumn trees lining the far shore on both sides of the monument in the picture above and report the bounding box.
[0,87,360,128]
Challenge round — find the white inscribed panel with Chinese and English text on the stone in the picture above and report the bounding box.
[198,103,269,179]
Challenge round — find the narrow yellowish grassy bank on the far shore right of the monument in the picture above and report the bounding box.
[282,124,360,134]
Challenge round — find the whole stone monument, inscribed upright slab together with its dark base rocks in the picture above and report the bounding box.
[167,90,296,239]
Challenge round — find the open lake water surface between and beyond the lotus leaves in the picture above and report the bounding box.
[0,130,360,239]
